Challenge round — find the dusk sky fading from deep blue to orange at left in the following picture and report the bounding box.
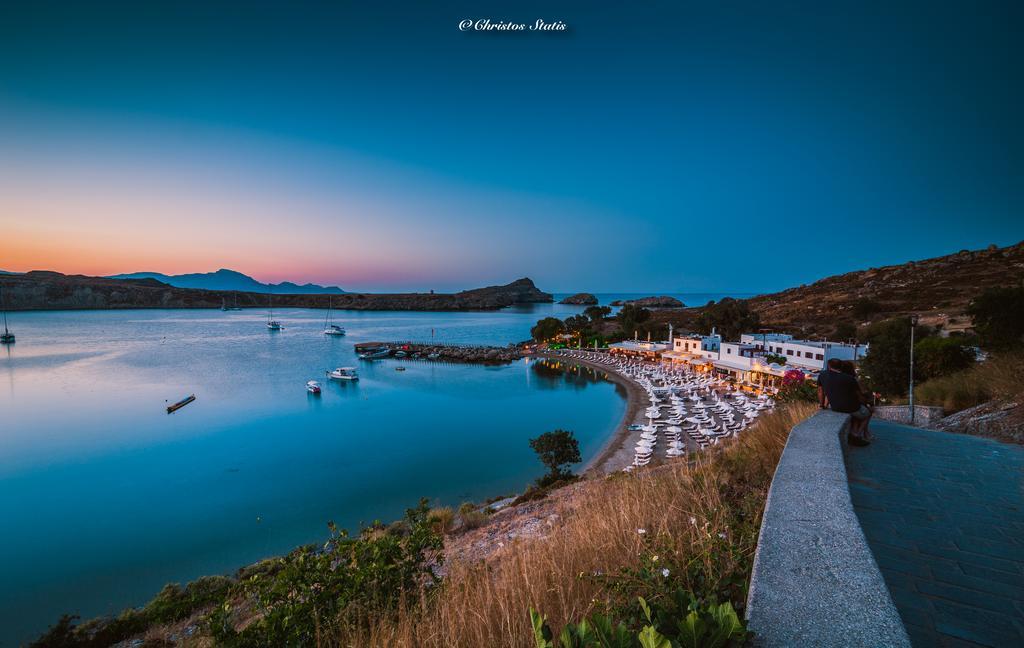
[0,0,1024,293]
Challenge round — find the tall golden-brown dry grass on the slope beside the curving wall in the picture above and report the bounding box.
[352,404,814,648]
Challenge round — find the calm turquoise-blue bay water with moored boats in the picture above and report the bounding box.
[0,296,745,646]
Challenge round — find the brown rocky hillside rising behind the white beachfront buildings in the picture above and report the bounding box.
[748,242,1024,335]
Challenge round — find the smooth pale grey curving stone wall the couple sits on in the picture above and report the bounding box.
[746,412,910,647]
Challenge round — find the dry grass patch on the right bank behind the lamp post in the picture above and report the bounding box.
[914,353,1024,414]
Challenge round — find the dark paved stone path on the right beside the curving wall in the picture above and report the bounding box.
[846,422,1024,646]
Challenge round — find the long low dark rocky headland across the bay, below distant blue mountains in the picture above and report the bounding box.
[0,271,553,310]
